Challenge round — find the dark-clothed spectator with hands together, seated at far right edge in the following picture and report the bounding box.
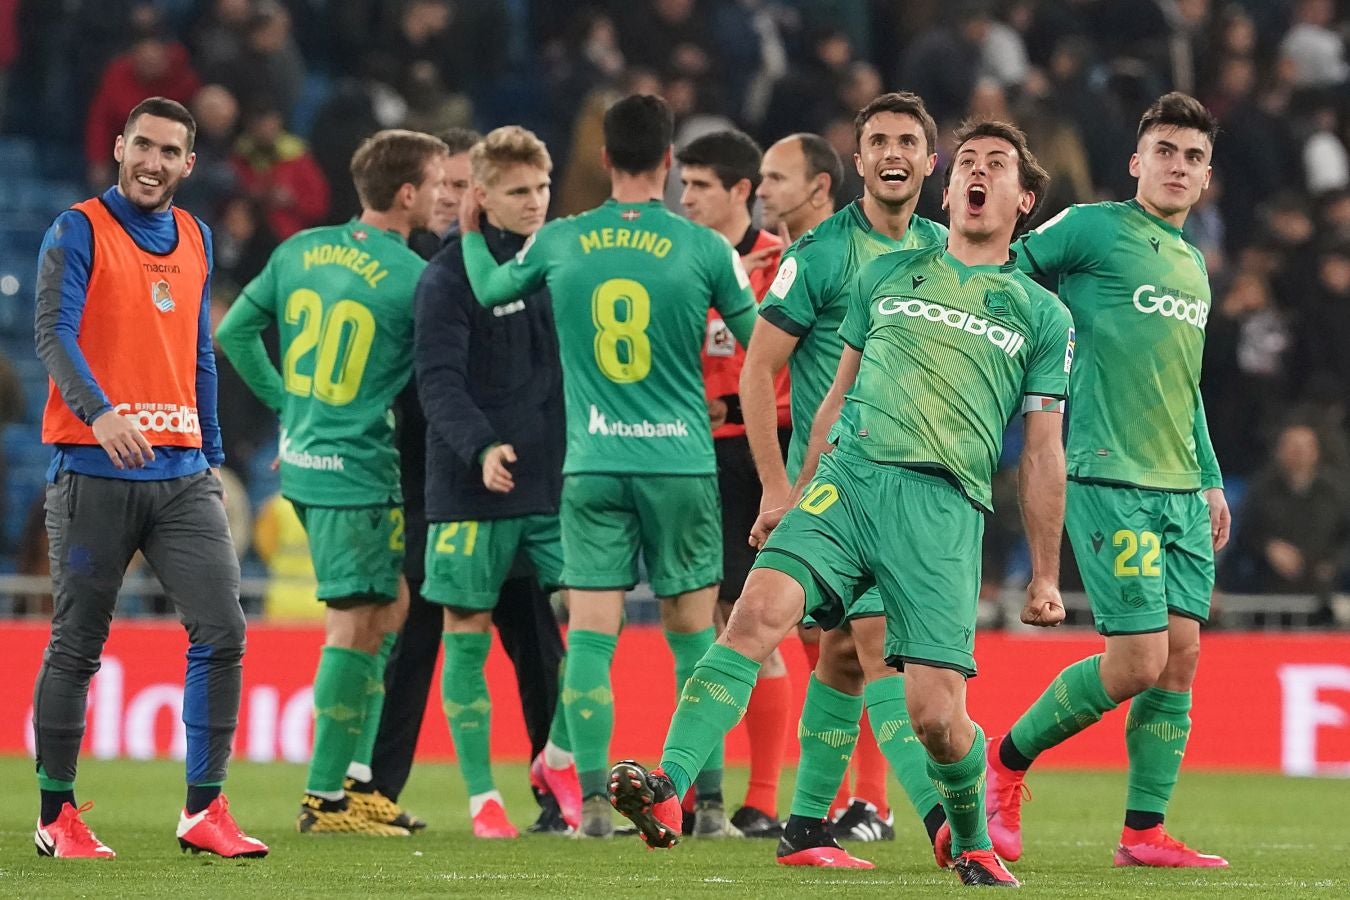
[1237,424,1350,594]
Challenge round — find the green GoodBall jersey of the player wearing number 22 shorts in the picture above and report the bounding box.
[1014,200,1222,490]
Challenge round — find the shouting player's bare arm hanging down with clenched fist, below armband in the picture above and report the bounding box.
[1018,412,1064,627]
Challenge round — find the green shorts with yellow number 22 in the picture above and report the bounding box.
[1064,480,1214,634]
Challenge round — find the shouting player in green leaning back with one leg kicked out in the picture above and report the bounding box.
[610,121,1073,887]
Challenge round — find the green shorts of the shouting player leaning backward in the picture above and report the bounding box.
[755,449,984,676]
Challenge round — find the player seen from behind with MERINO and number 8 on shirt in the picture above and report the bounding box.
[460,94,756,838]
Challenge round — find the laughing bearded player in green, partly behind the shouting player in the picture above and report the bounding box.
[741,93,946,866]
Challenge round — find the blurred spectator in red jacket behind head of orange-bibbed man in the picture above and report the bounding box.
[85,27,201,190]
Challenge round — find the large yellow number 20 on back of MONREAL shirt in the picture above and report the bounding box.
[282,287,375,406]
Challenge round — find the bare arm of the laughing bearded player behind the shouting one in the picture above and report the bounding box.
[741,318,798,513]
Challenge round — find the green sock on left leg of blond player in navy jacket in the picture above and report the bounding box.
[440,631,495,797]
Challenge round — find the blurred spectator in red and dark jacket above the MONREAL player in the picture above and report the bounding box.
[234,103,328,240]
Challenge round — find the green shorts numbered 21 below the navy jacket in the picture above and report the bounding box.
[423,515,563,611]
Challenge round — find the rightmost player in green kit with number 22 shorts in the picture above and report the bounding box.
[988,93,1229,868]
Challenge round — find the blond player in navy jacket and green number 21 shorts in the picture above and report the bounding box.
[416,125,581,838]
